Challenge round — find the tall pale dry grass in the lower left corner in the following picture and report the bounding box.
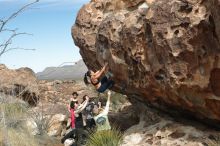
[0,96,37,146]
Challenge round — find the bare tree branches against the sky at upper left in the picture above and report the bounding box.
[0,0,39,57]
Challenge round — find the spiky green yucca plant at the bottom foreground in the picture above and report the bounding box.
[87,128,123,146]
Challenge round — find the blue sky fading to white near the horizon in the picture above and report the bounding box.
[0,0,89,72]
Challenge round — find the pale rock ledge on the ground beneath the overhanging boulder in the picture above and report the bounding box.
[121,104,220,146]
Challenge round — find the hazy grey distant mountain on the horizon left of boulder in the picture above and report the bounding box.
[36,60,88,80]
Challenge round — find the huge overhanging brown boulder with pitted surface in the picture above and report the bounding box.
[72,0,220,125]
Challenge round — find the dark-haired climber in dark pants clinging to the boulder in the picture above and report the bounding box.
[84,63,114,93]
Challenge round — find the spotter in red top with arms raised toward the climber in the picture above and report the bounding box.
[61,97,89,143]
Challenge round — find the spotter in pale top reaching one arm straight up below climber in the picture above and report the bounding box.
[94,91,111,131]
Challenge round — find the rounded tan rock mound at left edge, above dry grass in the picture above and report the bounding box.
[0,64,39,105]
